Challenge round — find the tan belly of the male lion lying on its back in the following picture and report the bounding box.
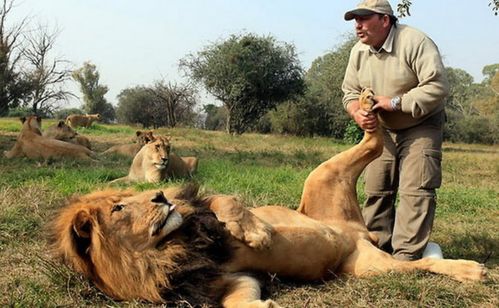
[227,206,352,280]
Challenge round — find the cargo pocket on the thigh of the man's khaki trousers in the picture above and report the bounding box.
[420,149,442,189]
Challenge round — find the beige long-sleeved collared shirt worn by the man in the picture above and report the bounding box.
[342,25,449,129]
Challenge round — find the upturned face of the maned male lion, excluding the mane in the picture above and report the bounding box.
[72,191,182,251]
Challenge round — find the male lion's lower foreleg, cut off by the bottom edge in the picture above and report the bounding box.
[222,274,281,308]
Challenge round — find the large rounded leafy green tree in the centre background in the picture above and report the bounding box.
[180,34,304,134]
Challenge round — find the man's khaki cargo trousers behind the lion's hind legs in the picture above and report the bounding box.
[362,112,444,260]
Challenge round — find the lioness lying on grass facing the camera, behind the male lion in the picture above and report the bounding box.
[112,137,197,183]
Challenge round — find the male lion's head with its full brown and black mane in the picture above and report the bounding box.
[50,188,229,303]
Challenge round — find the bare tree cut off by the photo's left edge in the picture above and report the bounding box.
[0,0,31,116]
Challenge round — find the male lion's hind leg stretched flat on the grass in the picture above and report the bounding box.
[342,240,487,282]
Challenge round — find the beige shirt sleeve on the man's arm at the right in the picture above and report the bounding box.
[401,37,449,118]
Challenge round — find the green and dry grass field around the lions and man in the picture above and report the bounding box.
[0,118,499,307]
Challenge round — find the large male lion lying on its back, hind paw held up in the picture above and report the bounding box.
[50,90,486,308]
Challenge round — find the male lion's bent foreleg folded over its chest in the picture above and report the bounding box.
[206,195,273,249]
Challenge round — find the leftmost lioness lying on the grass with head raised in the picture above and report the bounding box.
[4,116,94,159]
